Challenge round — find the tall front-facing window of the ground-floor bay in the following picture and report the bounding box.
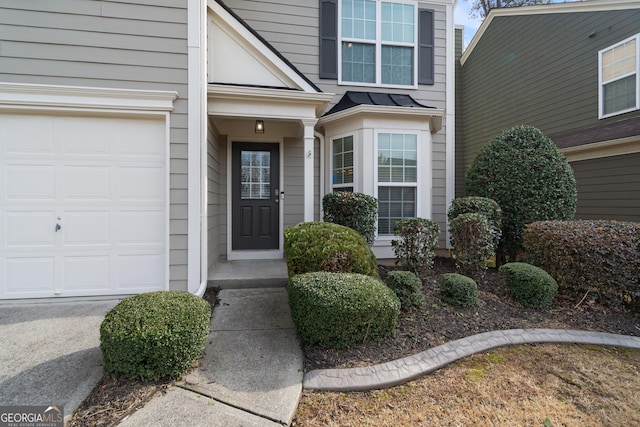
[378,133,418,236]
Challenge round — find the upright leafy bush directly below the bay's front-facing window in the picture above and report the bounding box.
[391,218,440,278]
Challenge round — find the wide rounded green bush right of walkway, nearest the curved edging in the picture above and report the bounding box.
[289,272,400,349]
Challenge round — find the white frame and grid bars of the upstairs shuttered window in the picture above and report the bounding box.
[338,0,418,89]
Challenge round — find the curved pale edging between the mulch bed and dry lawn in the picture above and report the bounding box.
[302,329,640,391]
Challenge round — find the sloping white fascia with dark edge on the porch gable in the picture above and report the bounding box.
[207,0,322,92]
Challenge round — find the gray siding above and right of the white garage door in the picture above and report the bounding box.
[0,0,187,289]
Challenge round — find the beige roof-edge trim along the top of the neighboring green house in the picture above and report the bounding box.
[460,0,640,65]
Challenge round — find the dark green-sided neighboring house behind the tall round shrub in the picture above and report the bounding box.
[456,0,640,221]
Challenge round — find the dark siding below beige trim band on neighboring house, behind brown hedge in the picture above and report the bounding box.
[571,153,640,221]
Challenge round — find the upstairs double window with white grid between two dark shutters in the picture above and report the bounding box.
[339,0,418,87]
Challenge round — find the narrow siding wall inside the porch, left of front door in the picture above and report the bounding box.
[207,123,227,271]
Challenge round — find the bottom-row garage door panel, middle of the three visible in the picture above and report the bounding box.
[63,256,111,291]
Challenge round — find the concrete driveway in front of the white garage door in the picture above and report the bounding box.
[0,300,118,422]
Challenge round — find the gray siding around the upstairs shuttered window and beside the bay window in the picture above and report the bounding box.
[224,0,447,245]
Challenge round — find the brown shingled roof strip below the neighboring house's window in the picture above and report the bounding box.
[549,116,640,149]
